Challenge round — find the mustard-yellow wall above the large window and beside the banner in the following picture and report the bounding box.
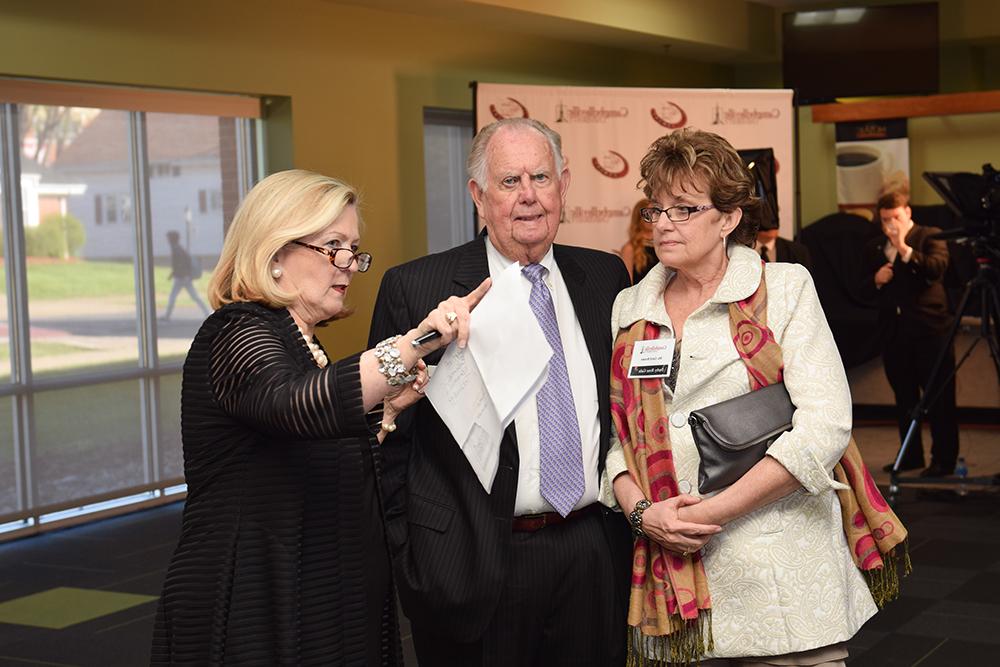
[0,0,731,355]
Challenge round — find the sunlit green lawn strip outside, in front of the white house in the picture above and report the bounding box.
[0,257,211,300]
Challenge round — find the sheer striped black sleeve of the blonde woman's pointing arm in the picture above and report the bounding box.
[209,316,371,439]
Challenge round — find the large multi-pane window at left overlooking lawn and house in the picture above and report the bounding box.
[0,79,259,539]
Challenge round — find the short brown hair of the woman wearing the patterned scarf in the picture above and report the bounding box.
[639,128,760,248]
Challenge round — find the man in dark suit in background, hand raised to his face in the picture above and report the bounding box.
[864,192,958,477]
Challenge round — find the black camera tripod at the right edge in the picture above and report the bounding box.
[889,238,1000,502]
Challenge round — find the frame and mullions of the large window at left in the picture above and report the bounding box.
[0,83,264,541]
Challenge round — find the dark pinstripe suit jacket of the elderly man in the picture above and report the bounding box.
[369,236,632,641]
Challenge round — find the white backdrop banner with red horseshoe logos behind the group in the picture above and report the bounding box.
[476,83,795,252]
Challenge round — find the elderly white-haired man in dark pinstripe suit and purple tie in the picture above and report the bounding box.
[371,118,632,667]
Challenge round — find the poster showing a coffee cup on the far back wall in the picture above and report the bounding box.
[836,118,910,211]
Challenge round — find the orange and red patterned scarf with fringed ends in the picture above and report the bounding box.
[611,272,910,667]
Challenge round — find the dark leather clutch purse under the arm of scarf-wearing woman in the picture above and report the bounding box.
[688,382,795,493]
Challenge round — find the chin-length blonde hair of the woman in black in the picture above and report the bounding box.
[208,169,358,309]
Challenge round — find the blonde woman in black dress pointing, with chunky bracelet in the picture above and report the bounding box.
[152,171,489,665]
